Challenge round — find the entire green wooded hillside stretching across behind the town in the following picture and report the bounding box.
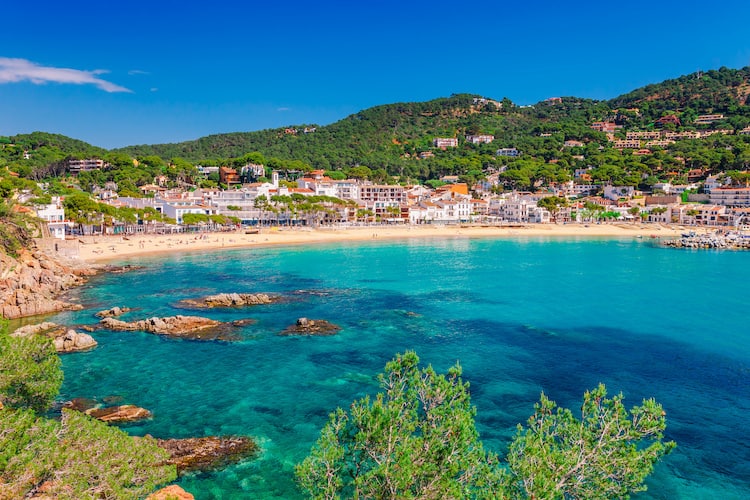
[0,67,750,194]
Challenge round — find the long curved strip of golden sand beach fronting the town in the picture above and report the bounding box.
[66,223,704,262]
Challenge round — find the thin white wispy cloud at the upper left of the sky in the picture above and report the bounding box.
[0,57,132,92]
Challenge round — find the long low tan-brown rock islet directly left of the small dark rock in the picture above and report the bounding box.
[99,315,252,340]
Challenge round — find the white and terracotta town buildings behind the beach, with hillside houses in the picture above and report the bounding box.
[26,123,750,239]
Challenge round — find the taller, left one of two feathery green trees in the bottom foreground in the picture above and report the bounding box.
[296,352,502,498]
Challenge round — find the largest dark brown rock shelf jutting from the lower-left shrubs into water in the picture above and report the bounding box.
[157,436,258,473]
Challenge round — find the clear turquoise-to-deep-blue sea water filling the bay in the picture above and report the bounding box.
[52,238,750,500]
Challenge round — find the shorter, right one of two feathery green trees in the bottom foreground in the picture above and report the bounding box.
[508,384,675,499]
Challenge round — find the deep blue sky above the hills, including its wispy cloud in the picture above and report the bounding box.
[0,0,750,148]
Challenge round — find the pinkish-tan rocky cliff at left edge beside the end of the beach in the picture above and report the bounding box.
[0,248,94,319]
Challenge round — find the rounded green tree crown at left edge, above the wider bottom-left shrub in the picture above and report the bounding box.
[0,325,63,413]
